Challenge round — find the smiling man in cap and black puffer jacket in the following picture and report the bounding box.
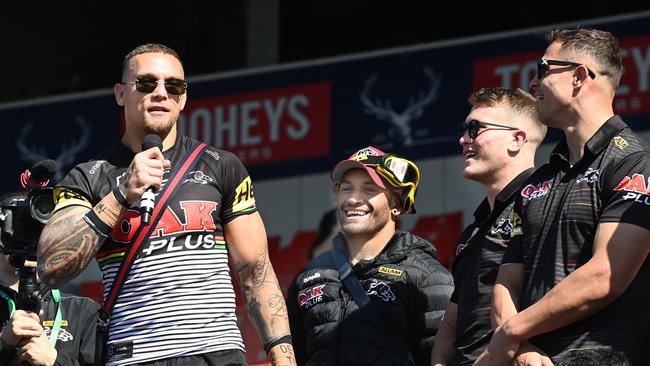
[287,147,453,366]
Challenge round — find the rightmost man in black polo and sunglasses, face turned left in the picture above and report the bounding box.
[477,29,650,366]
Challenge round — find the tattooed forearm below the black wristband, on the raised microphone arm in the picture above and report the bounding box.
[38,209,103,287]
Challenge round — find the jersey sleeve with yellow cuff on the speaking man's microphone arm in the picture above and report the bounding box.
[54,165,93,212]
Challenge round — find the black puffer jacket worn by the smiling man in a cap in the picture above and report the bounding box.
[287,231,453,366]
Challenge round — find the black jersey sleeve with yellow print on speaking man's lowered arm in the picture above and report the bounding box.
[210,152,257,224]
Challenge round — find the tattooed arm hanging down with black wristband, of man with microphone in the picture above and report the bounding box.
[225,213,296,366]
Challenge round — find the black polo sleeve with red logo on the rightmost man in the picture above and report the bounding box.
[599,151,650,230]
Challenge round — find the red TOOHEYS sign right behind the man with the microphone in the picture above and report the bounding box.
[179,82,332,165]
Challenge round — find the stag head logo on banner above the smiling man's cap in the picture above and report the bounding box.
[359,67,440,146]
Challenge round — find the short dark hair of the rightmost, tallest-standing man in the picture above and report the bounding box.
[546,28,623,88]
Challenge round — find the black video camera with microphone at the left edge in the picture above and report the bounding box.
[0,160,57,314]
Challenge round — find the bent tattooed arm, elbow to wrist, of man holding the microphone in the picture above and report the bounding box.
[37,193,125,288]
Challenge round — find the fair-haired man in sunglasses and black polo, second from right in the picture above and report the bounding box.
[431,88,546,365]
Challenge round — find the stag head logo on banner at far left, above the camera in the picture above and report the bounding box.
[16,116,91,182]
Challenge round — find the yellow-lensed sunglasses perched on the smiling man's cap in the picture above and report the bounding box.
[354,154,420,213]
